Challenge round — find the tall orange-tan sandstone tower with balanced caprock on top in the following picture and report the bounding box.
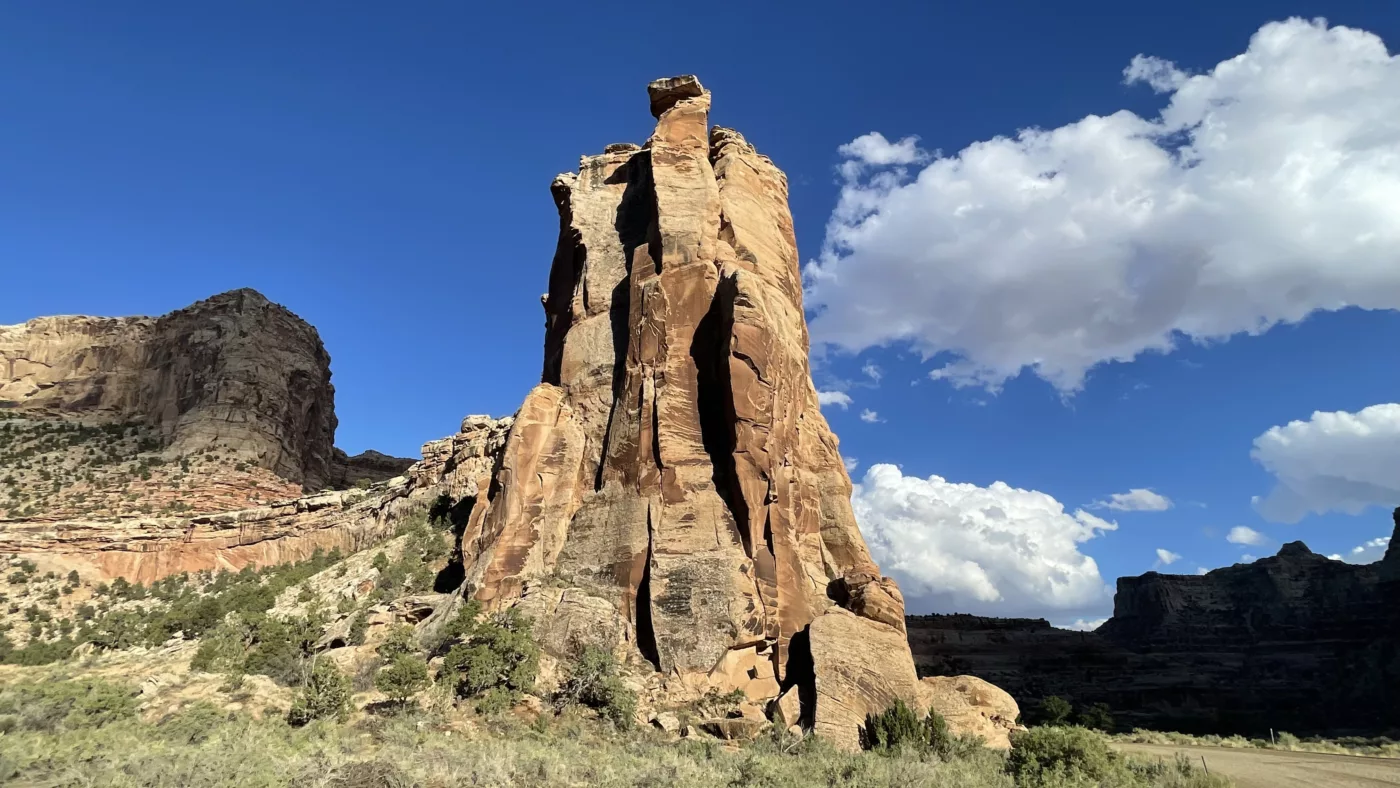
[462,77,920,746]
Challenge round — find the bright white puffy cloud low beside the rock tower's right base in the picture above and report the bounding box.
[851,465,1117,617]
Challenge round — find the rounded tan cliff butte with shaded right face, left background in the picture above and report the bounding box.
[0,290,336,490]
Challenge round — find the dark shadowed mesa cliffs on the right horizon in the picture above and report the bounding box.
[907,509,1400,736]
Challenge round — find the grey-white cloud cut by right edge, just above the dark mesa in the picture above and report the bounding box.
[1250,403,1400,522]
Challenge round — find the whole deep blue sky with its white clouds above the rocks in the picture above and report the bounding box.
[0,3,1400,623]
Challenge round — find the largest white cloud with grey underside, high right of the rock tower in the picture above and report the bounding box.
[806,20,1400,392]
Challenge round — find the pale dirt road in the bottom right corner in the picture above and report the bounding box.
[1114,745,1400,788]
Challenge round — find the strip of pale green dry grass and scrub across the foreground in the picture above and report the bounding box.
[0,673,1225,788]
